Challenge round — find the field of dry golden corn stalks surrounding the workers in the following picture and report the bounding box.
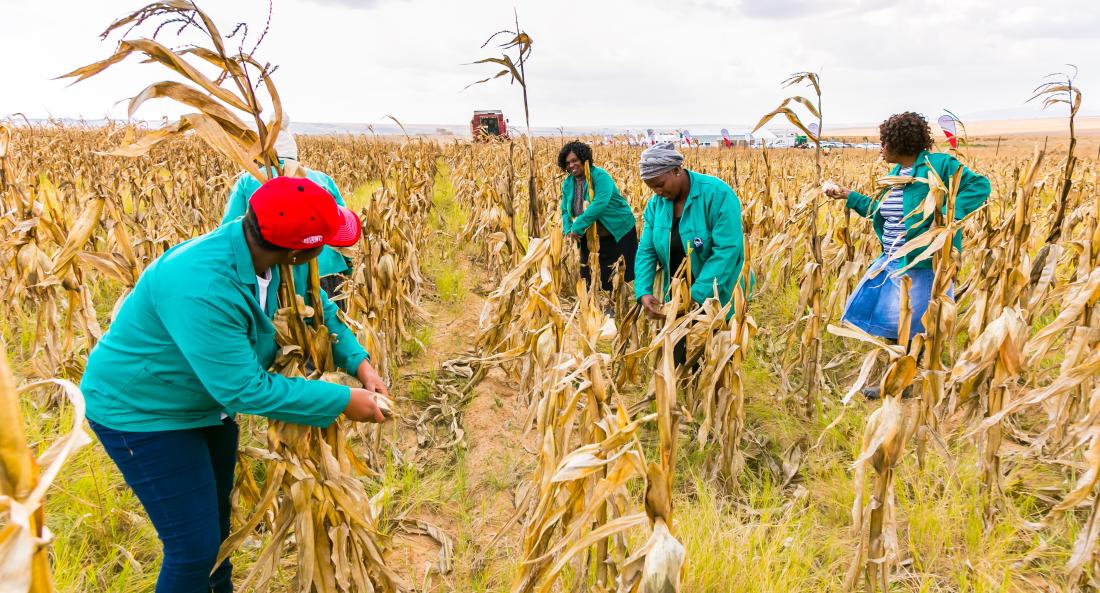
[0,122,1100,593]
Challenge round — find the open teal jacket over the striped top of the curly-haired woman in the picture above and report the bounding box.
[847,151,990,268]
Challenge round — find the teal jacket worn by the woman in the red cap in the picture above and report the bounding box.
[80,220,366,432]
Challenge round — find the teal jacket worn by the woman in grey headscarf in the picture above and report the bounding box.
[634,171,750,316]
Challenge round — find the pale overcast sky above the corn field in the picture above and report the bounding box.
[0,0,1100,129]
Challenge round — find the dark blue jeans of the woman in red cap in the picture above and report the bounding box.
[88,418,239,593]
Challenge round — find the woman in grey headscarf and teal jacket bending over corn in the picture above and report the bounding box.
[634,142,749,332]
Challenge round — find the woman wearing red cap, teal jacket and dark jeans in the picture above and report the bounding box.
[80,177,388,593]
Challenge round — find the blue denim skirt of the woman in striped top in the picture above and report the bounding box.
[844,255,955,340]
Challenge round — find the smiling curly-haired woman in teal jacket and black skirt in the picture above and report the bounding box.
[558,140,638,301]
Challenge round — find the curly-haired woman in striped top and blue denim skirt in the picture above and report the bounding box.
[826,111,990,347]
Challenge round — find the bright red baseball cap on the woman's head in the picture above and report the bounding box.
[249,177,363,249]
